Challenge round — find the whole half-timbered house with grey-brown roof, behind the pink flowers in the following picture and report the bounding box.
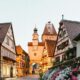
[55,20,80,62]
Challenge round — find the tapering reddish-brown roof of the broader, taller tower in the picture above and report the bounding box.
[43,21,57,35]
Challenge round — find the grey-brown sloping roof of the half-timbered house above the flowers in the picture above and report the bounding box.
[60,20,80,40]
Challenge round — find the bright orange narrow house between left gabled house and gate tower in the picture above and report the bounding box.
[16,45,30,77]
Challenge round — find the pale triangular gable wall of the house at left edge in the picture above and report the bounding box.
[2,25,15,53]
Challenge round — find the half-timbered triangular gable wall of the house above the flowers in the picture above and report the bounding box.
[55,21,73,55]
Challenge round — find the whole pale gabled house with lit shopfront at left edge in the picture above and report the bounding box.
[0,23,16,80]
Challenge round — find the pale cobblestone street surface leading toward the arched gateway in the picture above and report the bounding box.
[5,75,39,80]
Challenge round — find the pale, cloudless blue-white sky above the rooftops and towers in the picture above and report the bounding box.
[0,0,80,52]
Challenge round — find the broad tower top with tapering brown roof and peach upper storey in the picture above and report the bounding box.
[42,21,57,42]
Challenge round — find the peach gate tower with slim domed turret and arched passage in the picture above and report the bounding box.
[28,27,44,73]
